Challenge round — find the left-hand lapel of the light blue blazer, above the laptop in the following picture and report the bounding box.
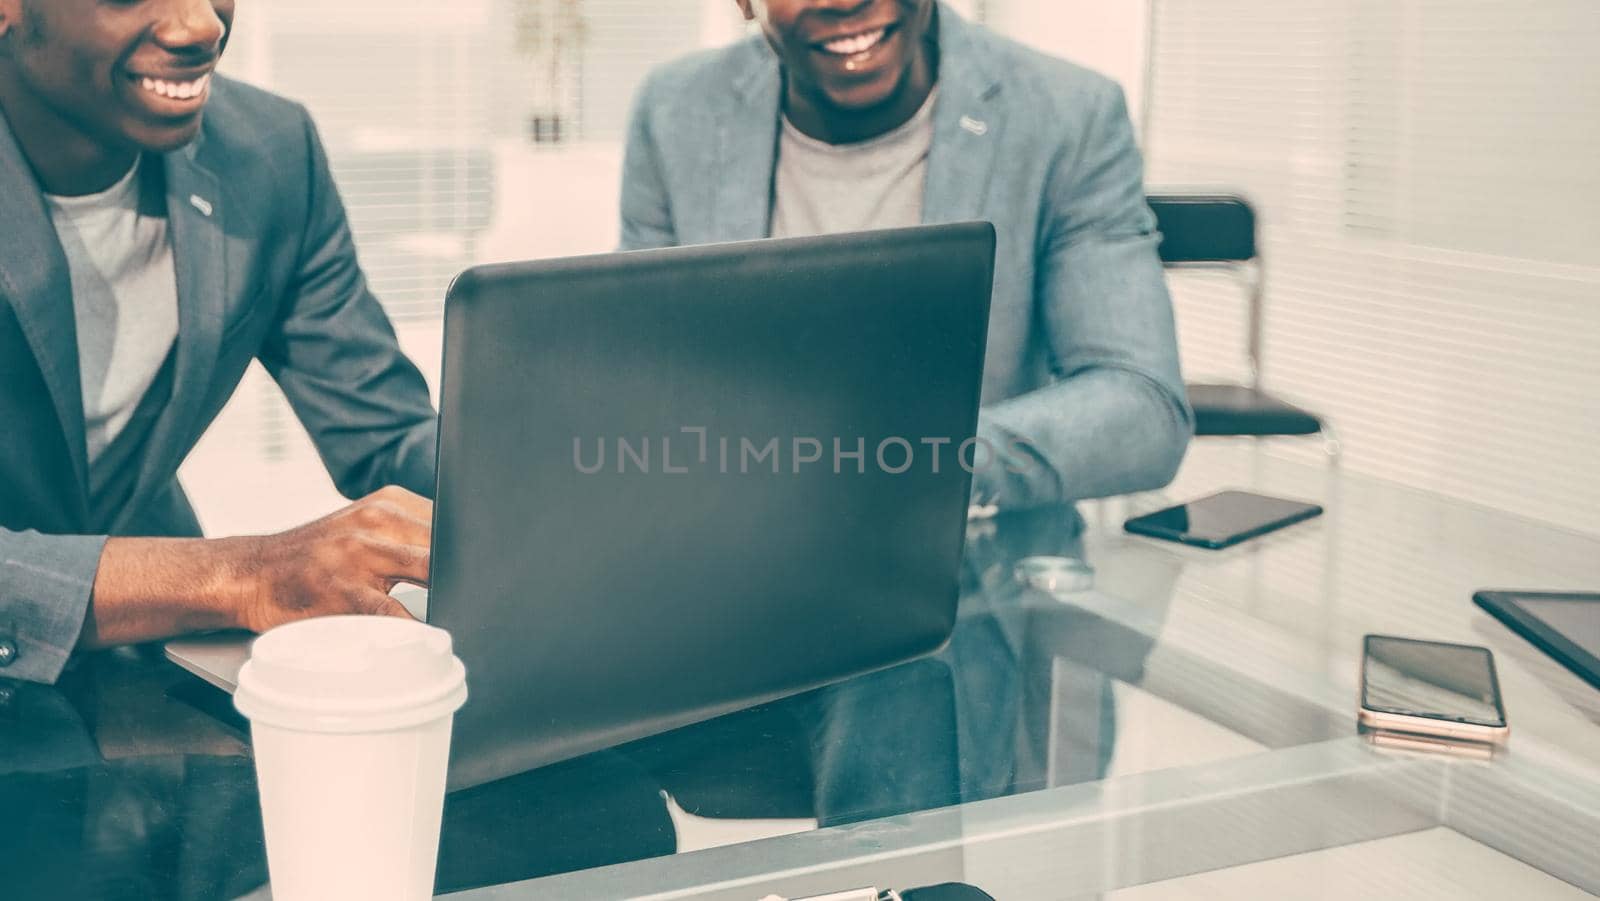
[710,42,782,242]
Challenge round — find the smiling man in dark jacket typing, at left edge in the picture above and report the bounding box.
[0,0,437,682]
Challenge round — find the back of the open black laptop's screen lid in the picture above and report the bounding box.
[427,222,995,787]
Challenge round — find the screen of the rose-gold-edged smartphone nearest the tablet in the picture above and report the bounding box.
[1362,635,1506,728]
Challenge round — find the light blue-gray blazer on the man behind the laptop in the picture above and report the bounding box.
[622,5,1192,507]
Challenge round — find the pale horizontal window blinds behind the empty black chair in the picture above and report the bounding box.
[1146,0,1600,533]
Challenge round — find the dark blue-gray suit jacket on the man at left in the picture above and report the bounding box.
[0,78,437,682]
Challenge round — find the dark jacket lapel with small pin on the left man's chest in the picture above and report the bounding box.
[115,136,227,527]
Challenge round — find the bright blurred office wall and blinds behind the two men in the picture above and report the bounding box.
[193,0,1600,535]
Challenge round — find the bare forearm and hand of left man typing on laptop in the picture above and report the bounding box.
[80,487,434,647]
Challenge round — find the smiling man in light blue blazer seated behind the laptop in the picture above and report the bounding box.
[621,0,1192,509]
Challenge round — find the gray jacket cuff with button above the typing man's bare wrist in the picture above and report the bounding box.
[0,528,106,682]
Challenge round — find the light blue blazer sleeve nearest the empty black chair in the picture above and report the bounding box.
[974,82,1194,507]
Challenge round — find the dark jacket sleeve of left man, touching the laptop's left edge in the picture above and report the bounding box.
[259,107,438,498]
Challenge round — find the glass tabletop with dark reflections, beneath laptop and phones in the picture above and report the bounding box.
[0,443,1600,901]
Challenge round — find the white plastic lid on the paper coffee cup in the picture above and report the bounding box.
[234,616,467,733]
